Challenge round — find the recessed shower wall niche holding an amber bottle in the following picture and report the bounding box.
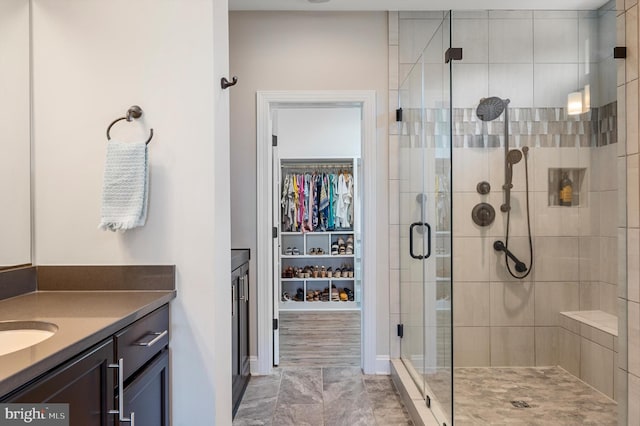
[548,167,587,207]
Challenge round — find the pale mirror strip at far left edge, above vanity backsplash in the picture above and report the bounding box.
[0,0,31,266]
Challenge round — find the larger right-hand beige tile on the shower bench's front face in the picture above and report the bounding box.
[580,338,615,398]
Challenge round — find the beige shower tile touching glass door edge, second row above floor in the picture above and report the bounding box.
[453,282,490,327]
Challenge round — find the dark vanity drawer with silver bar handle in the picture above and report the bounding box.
[115,305,169,380]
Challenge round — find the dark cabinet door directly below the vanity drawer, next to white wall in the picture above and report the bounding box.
[120,349,169,426]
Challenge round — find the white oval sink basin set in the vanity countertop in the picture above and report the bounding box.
[0,321,58,356]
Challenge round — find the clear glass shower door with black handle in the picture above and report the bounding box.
[399,13,453,424]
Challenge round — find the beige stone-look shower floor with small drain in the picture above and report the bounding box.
[454,367,618,426]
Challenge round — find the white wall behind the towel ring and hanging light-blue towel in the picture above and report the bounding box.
[33,0,231,425]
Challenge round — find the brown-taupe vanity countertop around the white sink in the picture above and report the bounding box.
[0,290,176,397]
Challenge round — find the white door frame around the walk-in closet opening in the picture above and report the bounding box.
[251,90,377,375]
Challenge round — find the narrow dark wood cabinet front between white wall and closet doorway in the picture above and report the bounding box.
[231,251,250,415]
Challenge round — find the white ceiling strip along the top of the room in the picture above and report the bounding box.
[229,0,606,11]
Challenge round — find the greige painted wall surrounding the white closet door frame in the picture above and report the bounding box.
[229,12,389,366]
